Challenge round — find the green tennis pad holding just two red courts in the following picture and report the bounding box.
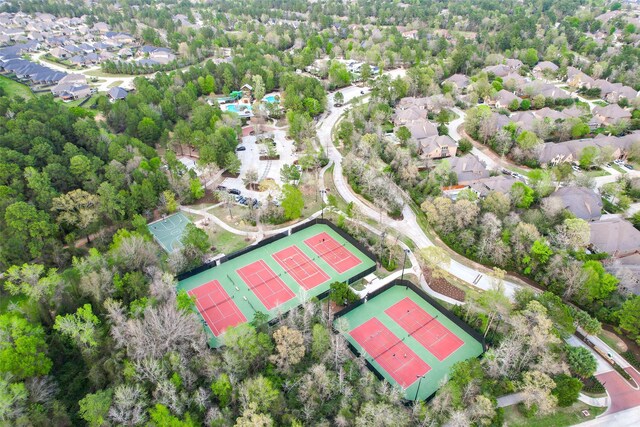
[334,285,483,400]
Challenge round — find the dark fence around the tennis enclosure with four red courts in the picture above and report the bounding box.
[176,218,376,284]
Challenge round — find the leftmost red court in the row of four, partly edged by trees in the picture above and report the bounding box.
[188,280,247,337]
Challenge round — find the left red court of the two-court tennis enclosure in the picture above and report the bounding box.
[350,317,431,389]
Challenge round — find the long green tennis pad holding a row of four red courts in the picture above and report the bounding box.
[178,224,375,347]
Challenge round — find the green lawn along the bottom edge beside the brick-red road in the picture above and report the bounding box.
[504,402,606,427]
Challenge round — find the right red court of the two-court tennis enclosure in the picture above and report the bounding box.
[384,298,464,361]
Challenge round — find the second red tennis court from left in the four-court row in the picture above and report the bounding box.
[236,260,295,310]
